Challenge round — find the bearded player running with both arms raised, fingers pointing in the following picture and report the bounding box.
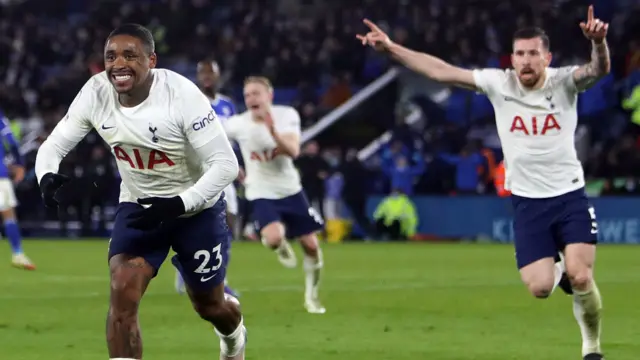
[357,6,610,360]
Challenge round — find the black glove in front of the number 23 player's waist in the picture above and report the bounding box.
[127,196,185,230]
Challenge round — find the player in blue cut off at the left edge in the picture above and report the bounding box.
[0,111,36,270]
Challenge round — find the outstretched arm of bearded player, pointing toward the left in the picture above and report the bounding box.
[356,19,476,90]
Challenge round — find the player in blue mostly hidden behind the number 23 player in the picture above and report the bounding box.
[174,61,238,297]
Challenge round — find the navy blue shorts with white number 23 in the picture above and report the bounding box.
[109,198,231,291]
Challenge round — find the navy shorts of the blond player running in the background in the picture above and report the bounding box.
[251,191,324,239]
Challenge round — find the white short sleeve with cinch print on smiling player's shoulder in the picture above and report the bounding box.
[178,84,225,148]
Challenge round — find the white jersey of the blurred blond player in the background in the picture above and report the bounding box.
[225,105,302,200]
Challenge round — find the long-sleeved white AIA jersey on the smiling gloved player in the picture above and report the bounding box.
[36,69,237,213]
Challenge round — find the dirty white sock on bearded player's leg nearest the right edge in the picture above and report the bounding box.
[573,282,602,356]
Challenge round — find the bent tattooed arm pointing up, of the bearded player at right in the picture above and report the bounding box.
[573,5,611,91]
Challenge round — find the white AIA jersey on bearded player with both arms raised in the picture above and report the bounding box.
[473,67,585,198]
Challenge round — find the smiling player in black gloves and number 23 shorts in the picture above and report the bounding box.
[35,24,246,360]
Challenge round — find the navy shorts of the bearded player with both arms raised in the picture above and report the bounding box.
[511,189,598,269]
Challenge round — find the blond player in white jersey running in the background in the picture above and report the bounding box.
[225,77,325,314]
